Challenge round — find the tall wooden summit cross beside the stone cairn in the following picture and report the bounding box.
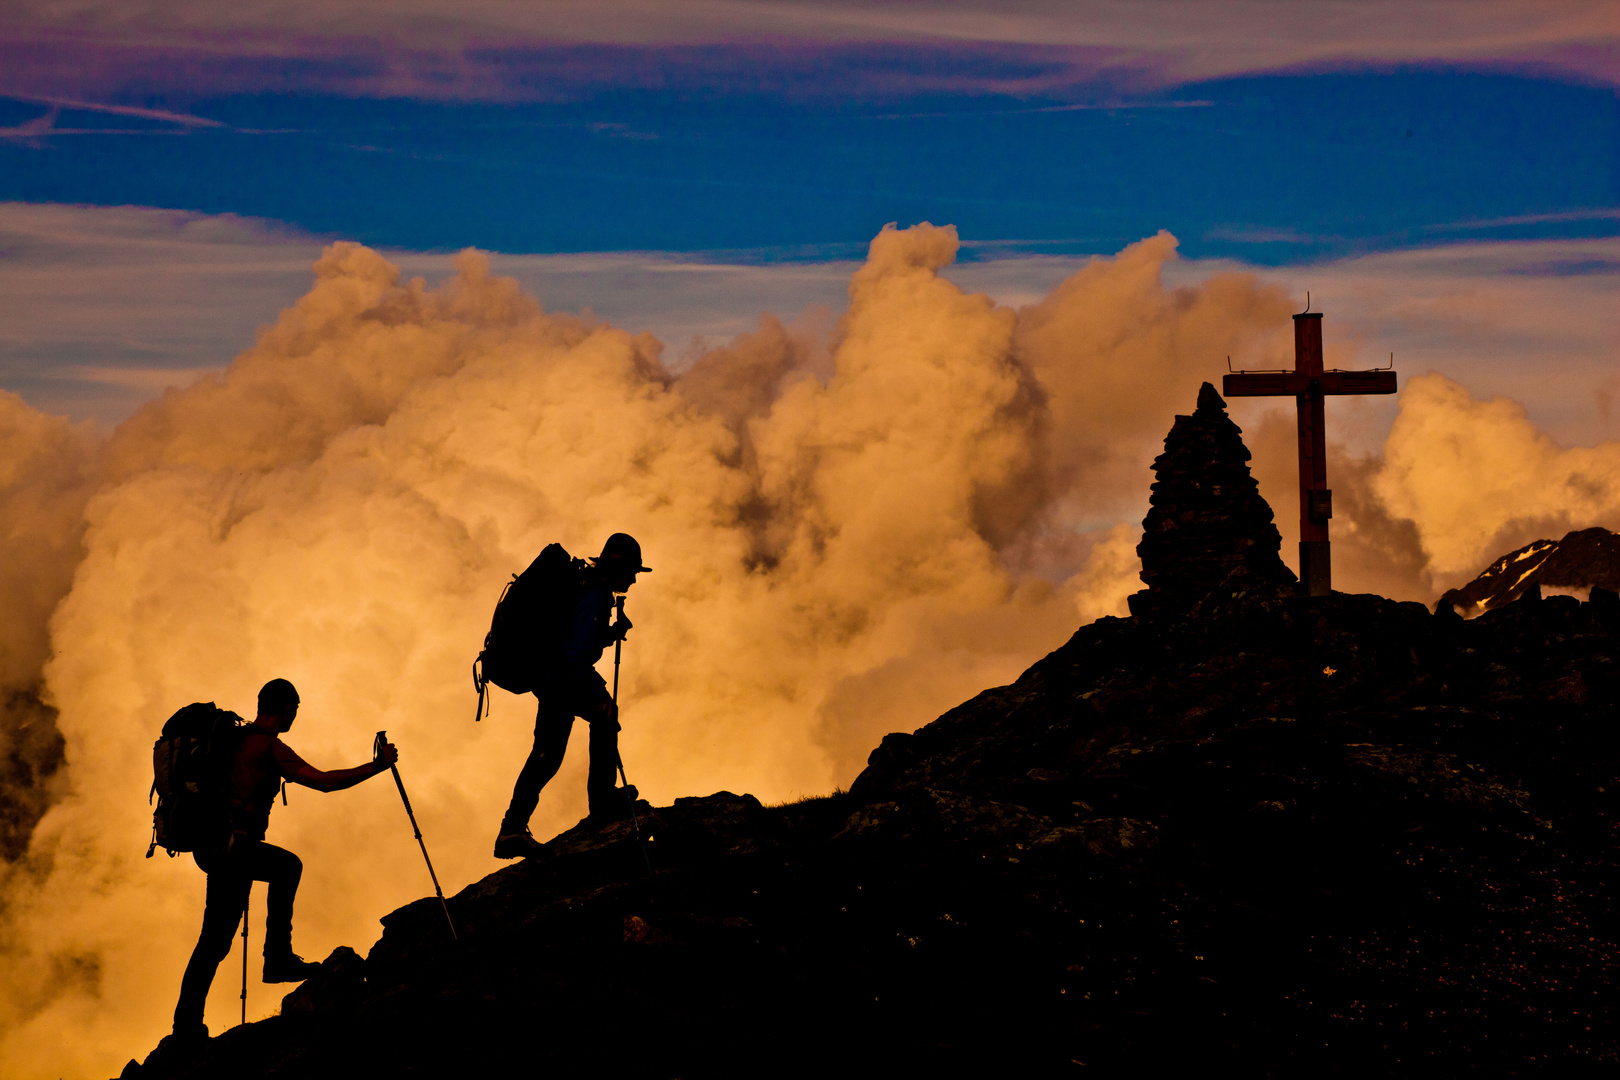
[1221,311,1395,596]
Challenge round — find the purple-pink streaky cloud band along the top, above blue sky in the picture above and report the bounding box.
[0,0,1620,100]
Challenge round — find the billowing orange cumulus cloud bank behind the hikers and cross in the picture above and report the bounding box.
[0,225,1609,1077]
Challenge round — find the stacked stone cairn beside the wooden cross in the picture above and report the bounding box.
[1129,382,1294,617]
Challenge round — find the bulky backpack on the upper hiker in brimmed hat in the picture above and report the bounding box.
[473,544,590,721]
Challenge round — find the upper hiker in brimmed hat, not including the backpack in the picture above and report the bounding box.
[496,533,651,858]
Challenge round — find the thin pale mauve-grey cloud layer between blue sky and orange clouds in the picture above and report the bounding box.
[0,202,1620,453]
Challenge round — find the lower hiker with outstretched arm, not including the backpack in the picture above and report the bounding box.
[172,678,399,1041]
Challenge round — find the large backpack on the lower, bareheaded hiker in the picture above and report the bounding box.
[146,701,246,858]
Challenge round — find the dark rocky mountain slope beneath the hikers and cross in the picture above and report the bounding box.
[125,388,1620,1078]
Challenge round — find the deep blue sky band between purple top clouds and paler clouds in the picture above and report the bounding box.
[0,65,1620,266]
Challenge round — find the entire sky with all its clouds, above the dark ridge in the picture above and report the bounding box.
[0,0,1620,1077]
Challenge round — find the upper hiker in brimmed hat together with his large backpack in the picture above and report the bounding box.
[475,533,651,858]
